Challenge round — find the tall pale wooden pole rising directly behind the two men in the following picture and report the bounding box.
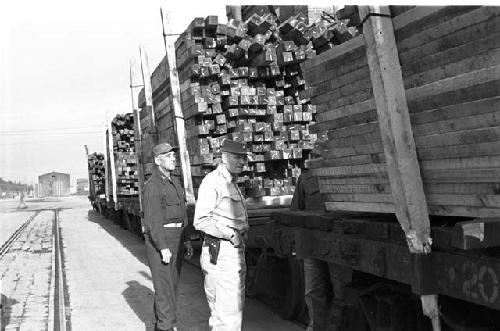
[160,8,195,206]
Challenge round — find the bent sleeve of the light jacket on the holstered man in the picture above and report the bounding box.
[193,177,234,239]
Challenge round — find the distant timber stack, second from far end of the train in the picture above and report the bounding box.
[111,113,139,196]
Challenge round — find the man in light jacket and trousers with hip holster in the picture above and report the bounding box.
[193,140,248,331]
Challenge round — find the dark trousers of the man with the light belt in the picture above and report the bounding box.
[145,228,184,330]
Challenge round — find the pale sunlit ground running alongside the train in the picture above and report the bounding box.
[0,196,302,331]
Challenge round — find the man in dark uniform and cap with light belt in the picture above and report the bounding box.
[143,143,193,331]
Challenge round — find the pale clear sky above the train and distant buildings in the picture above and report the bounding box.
[0,0,478,185]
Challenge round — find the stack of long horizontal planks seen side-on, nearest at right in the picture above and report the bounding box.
[302,6,500,217]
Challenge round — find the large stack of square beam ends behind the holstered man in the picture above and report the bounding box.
[176,14,358,197]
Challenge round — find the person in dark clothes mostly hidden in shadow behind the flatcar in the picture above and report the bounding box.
[290,154,352,331]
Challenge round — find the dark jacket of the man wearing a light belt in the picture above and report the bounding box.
[143,166,188,250]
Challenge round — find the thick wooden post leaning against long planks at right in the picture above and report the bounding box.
[359,6,441,331]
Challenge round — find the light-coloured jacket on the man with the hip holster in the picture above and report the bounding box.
[193,164,248,239]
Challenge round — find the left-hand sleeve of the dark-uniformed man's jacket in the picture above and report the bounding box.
[144,183,167,250]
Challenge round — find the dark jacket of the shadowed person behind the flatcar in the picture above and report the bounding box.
[290,169,325,210]
